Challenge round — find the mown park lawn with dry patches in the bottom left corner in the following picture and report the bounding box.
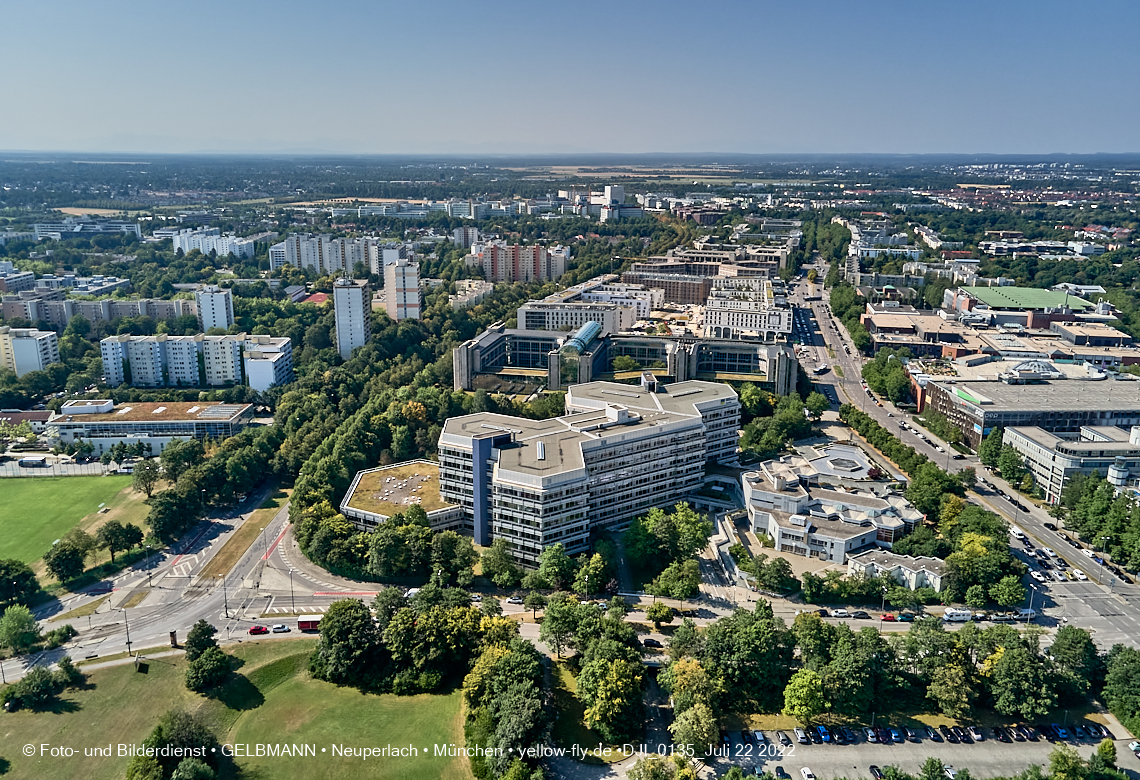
[0,639,471,780]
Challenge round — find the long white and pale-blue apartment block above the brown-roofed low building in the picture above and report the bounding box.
[99,333,293,392]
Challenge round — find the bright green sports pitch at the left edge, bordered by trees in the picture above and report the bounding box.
[0,474,131,563]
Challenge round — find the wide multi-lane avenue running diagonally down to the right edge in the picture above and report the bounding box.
[791,262,1140,650]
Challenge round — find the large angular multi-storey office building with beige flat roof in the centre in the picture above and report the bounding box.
[439,377,740,566]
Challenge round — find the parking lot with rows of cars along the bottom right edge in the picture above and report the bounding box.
[709,730,1140,780]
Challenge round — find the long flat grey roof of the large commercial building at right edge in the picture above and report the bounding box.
[935,380,1140,412]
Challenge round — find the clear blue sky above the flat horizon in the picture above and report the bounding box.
[0,0,1140,154]
